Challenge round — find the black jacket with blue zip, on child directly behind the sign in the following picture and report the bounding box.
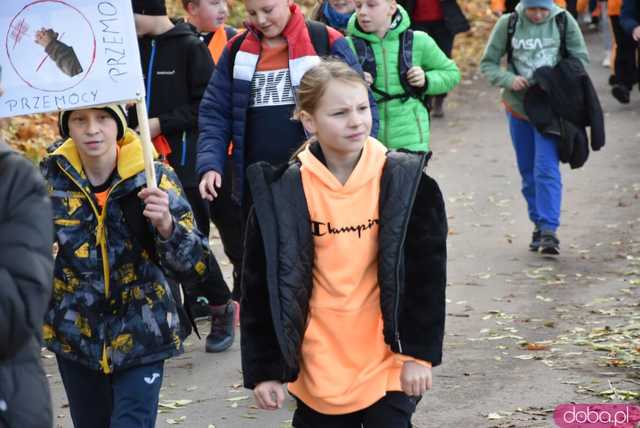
[129,22,214,188]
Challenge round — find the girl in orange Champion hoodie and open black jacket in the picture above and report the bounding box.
[241,61,448,428]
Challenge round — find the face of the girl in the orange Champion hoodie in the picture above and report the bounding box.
[300,80,371,155]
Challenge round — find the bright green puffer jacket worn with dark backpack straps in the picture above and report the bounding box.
[347,6,460,151]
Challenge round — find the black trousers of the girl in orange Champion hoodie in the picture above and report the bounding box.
[293,391,420,428]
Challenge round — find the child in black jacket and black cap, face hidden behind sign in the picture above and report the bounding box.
[130,0,236,351]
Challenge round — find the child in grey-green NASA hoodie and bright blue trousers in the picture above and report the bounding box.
[480,0,589,255]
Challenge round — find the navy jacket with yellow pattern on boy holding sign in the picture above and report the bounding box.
[43,130,209,373]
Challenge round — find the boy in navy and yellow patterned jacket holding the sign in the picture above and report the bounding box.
[43,105,209,428]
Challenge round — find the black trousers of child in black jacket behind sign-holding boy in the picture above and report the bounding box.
[182,187,231,305]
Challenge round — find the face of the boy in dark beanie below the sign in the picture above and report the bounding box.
[69,109,118,159]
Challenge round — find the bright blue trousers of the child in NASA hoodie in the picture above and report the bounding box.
[507,113,562,232]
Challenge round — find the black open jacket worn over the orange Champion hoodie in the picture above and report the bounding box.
[240,147,448,389]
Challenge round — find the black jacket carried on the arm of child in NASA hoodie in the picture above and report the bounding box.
[524,57,605,169]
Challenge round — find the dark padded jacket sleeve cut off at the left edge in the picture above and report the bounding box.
[0,141,53,428]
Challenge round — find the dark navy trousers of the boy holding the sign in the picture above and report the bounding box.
[58,357,164,428]
